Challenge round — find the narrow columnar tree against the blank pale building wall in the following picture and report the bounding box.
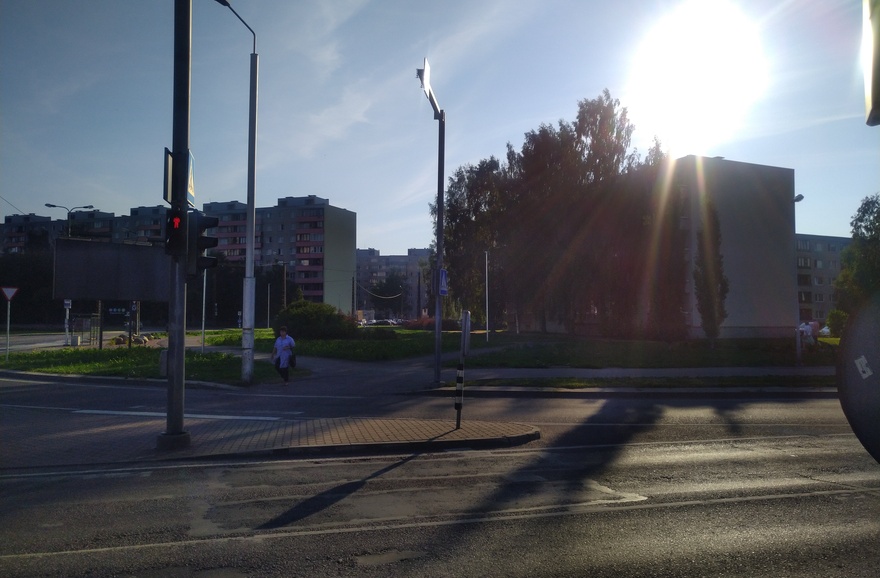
[694,199,730,344]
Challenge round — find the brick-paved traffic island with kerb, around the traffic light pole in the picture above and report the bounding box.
[0,408,540,470]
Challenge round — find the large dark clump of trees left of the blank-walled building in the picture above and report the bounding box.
[440,89,684,334]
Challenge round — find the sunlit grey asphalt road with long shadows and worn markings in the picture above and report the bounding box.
[0,375,880,578]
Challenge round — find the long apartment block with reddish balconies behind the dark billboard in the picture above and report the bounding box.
[0,195,357,315]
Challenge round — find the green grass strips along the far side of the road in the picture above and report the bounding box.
[0,328,838,388]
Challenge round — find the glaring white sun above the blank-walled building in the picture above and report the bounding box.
[621,0,768,157]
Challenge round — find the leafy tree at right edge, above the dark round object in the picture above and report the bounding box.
[834,193,880,314]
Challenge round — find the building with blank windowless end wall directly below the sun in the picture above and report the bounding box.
[672,156,799,338]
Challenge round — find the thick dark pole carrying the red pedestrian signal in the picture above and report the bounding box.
[156,0,192,449]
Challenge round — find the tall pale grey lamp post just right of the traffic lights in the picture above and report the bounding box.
[216,0,260,383]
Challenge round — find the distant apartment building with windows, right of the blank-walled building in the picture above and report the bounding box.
[796,233,852,324]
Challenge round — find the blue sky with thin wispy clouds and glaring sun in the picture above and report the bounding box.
[0,0,880,255]
